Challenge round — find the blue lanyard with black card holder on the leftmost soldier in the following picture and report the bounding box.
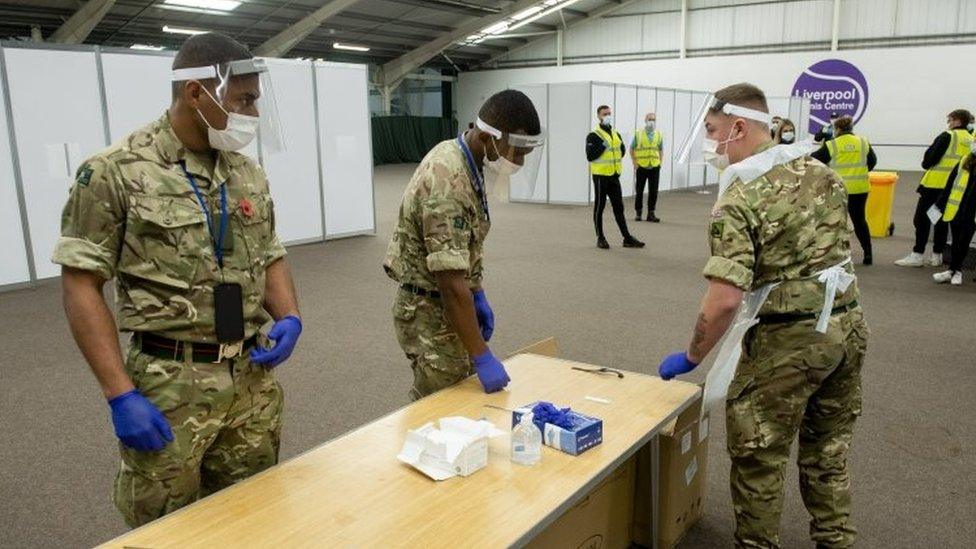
[180,162,244,343]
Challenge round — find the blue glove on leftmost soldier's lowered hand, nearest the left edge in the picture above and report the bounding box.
[108,389,173,452]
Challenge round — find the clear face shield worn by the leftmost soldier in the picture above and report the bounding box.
[172,57,285,152]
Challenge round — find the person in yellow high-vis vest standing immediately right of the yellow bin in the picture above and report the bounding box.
[895,109,973,267]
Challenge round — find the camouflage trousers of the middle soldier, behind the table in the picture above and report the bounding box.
[393,289,474,400]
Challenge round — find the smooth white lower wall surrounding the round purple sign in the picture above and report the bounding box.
[458,42,976,170]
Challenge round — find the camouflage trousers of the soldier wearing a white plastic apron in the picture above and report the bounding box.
[726,307,868,548]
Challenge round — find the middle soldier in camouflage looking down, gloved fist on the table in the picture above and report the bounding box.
[383,90,540,399]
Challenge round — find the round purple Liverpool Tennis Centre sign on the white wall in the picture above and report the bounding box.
[792,59,868,133]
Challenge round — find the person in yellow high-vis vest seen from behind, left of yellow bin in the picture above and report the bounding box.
[810,116,878,265]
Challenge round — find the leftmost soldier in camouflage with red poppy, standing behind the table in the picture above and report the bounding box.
[53,34,301,527]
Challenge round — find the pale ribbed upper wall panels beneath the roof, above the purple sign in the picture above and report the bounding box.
[497,0,976,66]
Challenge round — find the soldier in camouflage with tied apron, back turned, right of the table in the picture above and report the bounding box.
[660,84,868,548]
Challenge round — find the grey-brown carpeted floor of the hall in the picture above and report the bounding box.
[0,165,976,548]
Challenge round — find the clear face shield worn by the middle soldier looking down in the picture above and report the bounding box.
[476,118,546,201]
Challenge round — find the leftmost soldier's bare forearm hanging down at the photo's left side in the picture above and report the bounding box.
[61,267,134,398]
